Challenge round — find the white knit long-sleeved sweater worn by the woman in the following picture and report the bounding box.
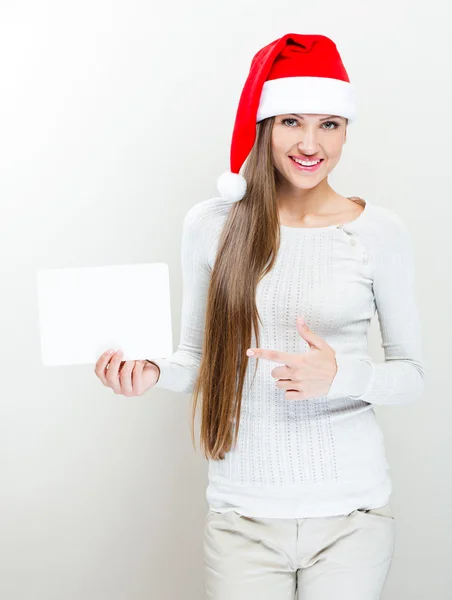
[152,198,424,518]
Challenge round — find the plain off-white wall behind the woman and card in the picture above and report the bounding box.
[0,0,452,600]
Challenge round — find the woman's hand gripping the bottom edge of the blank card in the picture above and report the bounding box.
[94,351,160,397]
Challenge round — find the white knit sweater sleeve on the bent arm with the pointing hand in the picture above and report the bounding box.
[327,213,424,404]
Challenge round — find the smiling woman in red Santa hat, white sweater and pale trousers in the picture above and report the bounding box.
[95,34,424,600]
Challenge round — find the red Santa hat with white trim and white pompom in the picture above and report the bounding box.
[217,33,356,202]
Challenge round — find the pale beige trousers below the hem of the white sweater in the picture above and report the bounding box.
[204,503,395,600]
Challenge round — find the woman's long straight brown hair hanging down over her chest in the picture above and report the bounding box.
[191,117,348,460]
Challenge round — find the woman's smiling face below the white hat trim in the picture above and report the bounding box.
[272,114,347,189]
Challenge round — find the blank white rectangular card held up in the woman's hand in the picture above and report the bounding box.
[37,263,173,366]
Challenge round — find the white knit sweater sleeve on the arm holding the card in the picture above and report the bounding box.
[150,202,211,393]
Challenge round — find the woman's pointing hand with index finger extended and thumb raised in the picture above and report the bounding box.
[247,319,337,400]
